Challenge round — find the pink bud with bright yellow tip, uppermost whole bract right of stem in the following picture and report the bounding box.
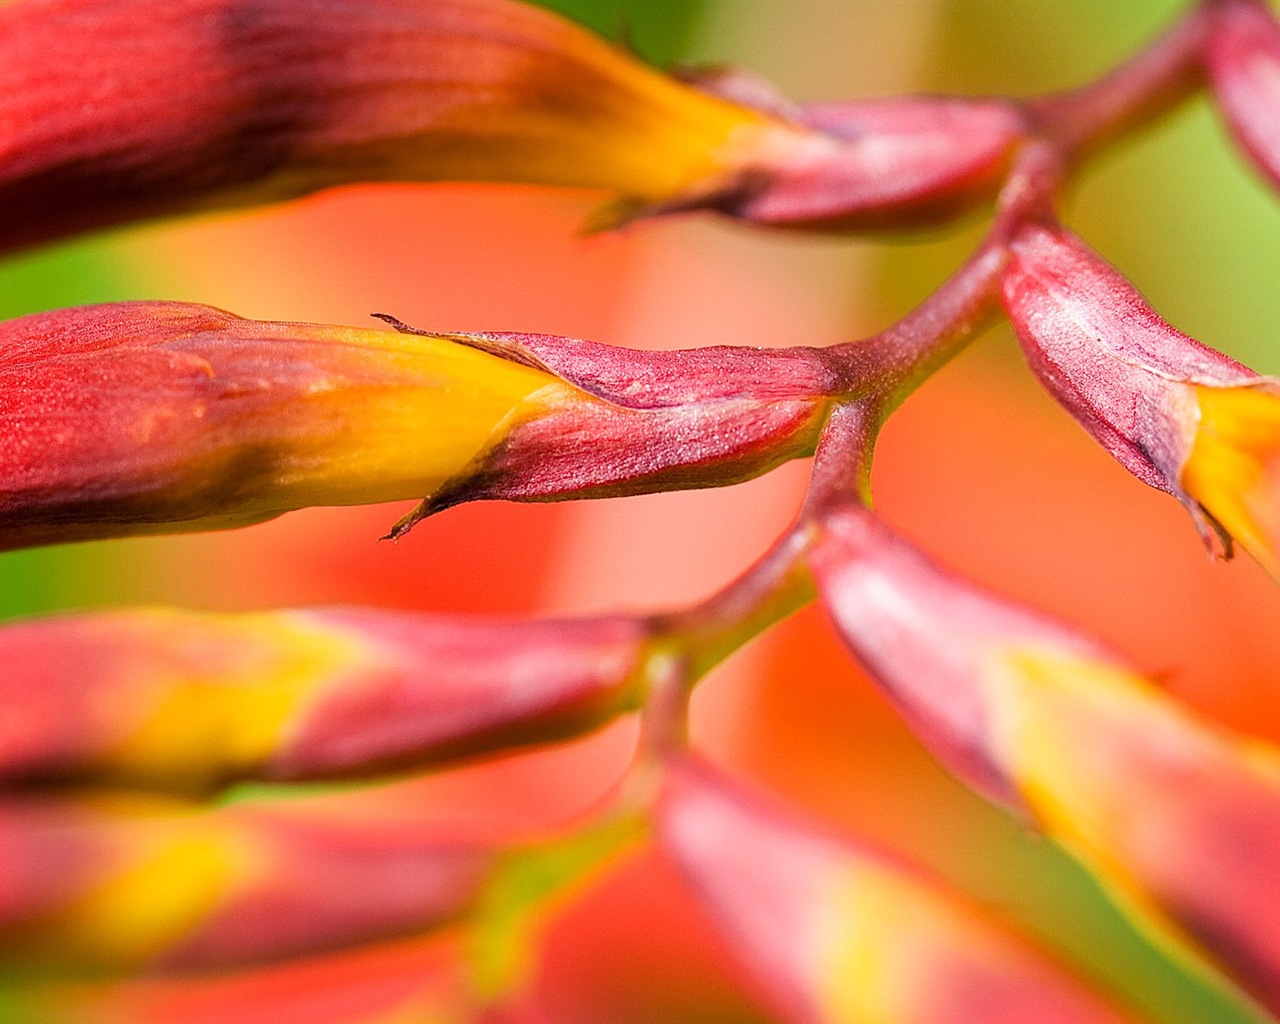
[1004,225,1280,575]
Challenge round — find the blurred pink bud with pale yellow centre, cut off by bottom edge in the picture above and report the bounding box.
[658,762,1124,1024]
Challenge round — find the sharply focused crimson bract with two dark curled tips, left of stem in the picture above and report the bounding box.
[392,320,841,535]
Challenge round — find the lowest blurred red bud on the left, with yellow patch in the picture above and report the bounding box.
[0,794,493,970]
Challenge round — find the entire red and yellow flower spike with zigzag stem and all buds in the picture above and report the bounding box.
[0,0,1280,1024]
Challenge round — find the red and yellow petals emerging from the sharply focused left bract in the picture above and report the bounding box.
[0,302,568,548]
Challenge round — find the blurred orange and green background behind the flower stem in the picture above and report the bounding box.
[0,0,1280,1024]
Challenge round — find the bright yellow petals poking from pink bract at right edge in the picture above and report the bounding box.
[1181,384,1280,580]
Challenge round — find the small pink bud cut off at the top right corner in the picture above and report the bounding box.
[1204,0,1280,193]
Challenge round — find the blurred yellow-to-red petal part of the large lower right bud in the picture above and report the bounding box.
[992,649,1280,1012]
